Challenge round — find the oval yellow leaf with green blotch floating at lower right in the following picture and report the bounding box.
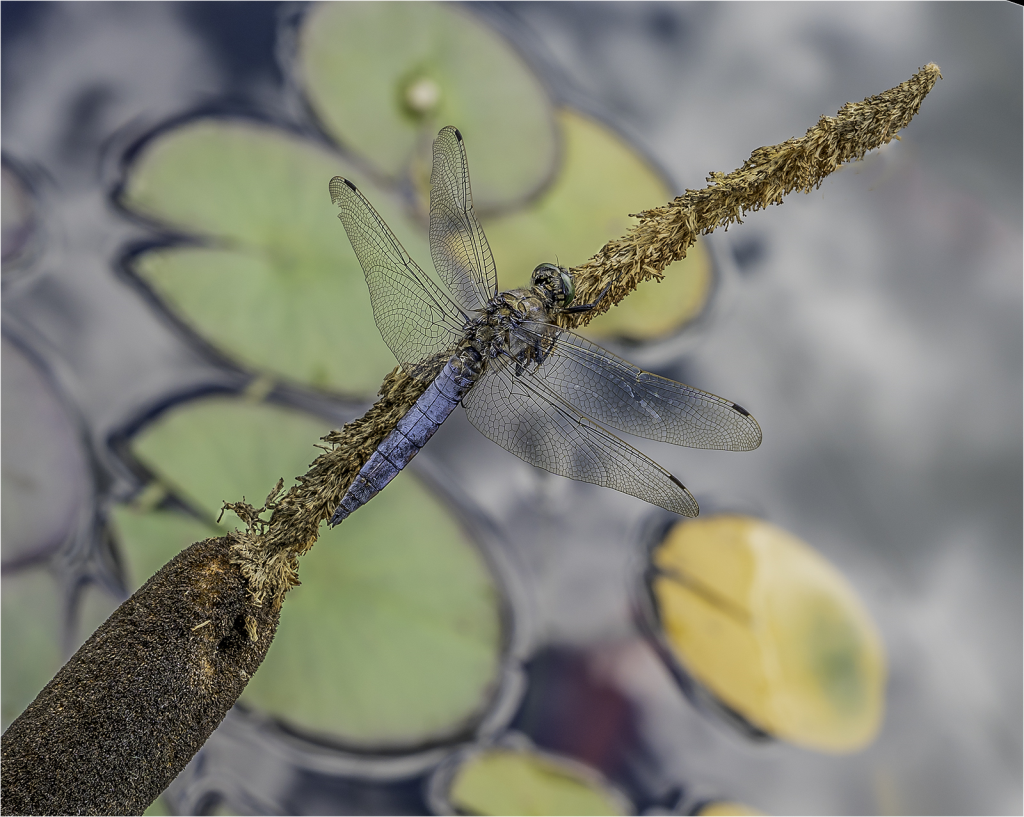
[651,515,886,753]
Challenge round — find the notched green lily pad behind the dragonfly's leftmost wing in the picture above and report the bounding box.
[122,120,419,394]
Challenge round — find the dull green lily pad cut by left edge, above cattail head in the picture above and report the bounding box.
[0,569,63,729]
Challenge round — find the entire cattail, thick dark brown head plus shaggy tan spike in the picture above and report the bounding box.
[2,63,940,814]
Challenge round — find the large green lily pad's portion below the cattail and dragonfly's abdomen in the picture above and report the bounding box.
[243,474,502,749]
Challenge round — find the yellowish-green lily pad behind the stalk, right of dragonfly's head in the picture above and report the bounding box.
[474,109,712,340]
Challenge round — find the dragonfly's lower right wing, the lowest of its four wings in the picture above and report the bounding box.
[462,357,698,516]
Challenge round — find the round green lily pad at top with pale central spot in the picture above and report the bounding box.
[297,3,557,210]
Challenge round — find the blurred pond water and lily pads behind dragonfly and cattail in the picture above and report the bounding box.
[0,2,1024,814]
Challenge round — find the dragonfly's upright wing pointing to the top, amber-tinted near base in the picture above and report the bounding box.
[430,125,498,312]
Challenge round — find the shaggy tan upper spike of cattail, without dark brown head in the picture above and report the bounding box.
[232,63,940,599]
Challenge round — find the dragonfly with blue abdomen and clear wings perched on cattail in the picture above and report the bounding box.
[330,126,761,526]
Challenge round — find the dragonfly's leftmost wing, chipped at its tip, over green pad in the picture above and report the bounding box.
[331,176,466,373]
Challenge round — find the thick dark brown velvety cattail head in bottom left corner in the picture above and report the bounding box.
[0,536,280,814]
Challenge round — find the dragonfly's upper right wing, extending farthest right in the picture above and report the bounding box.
[514,321,761,452]
